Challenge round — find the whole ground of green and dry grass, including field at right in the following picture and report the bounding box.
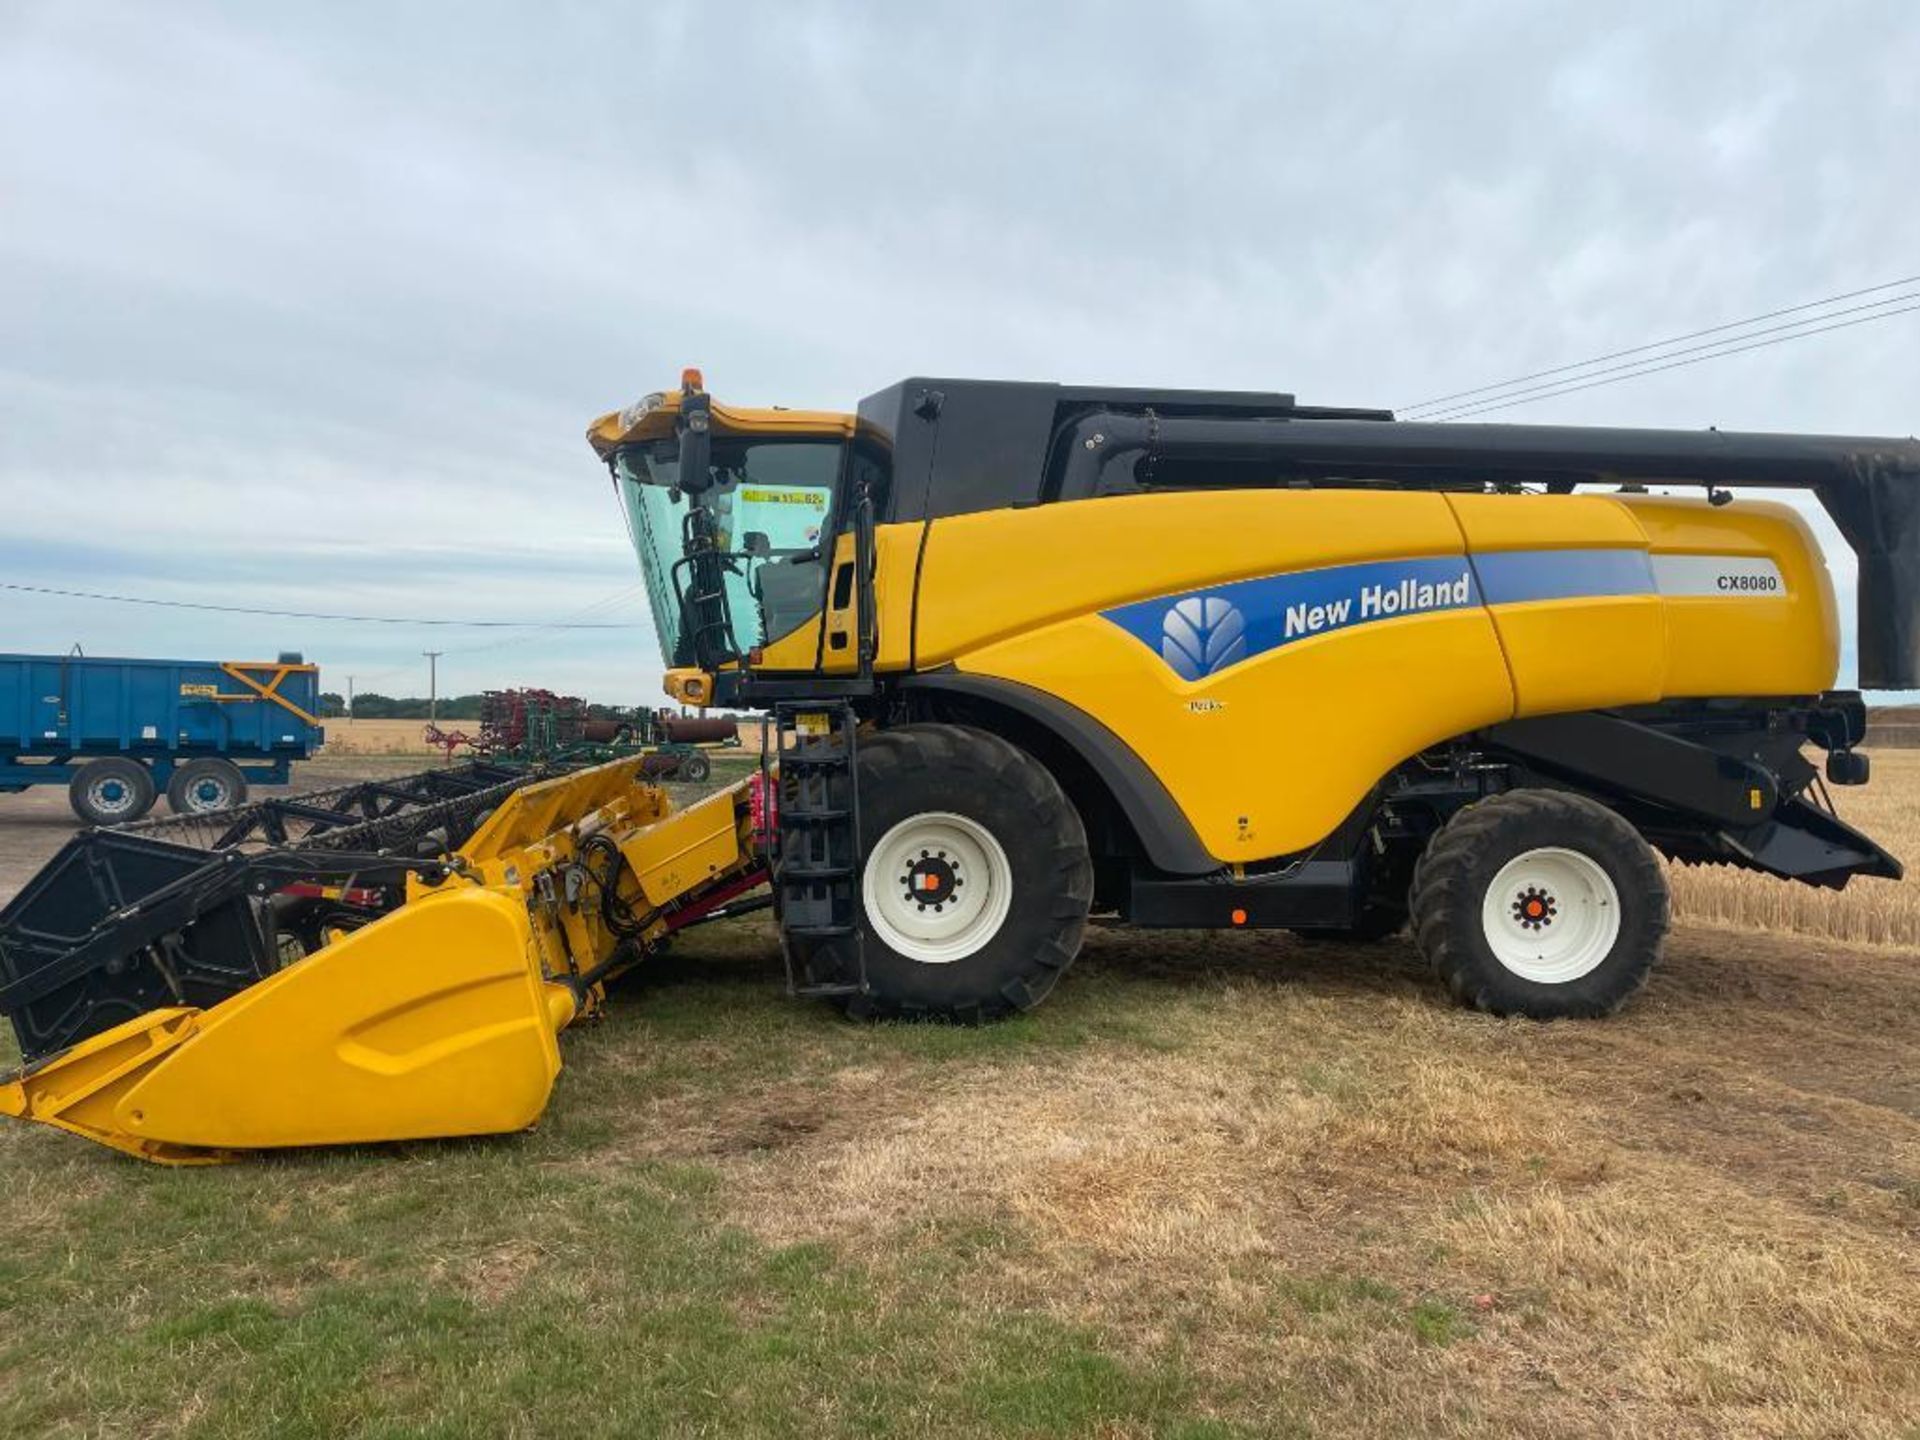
[0,748,1920,1438]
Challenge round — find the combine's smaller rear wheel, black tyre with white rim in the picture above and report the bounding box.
[1411,789,1668,1020]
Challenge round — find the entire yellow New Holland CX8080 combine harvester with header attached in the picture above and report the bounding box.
[0,371,1920,1162]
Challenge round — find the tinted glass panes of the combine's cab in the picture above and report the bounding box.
[614,434,843,666]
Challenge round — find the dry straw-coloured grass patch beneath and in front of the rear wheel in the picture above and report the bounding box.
[622,933,1920,1436]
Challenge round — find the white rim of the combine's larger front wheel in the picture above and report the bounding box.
[860,810,1014,966]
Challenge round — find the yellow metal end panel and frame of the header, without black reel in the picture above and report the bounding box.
[0,756,755,1164]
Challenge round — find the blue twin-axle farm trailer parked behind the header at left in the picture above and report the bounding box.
[0,649,326,826]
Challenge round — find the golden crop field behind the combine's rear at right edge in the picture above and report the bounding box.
[1672,749,1920,947]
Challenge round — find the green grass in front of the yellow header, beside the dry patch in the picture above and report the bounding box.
[0,931,1231,1436]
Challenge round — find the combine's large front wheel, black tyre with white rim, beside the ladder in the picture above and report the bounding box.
[806,724,1092,1023]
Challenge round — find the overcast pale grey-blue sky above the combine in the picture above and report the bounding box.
[0,0,1920,703]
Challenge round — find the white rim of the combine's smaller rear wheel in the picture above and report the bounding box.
[1480,847,1620,985]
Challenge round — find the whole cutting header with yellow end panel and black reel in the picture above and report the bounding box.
[0,756,764,1165]
